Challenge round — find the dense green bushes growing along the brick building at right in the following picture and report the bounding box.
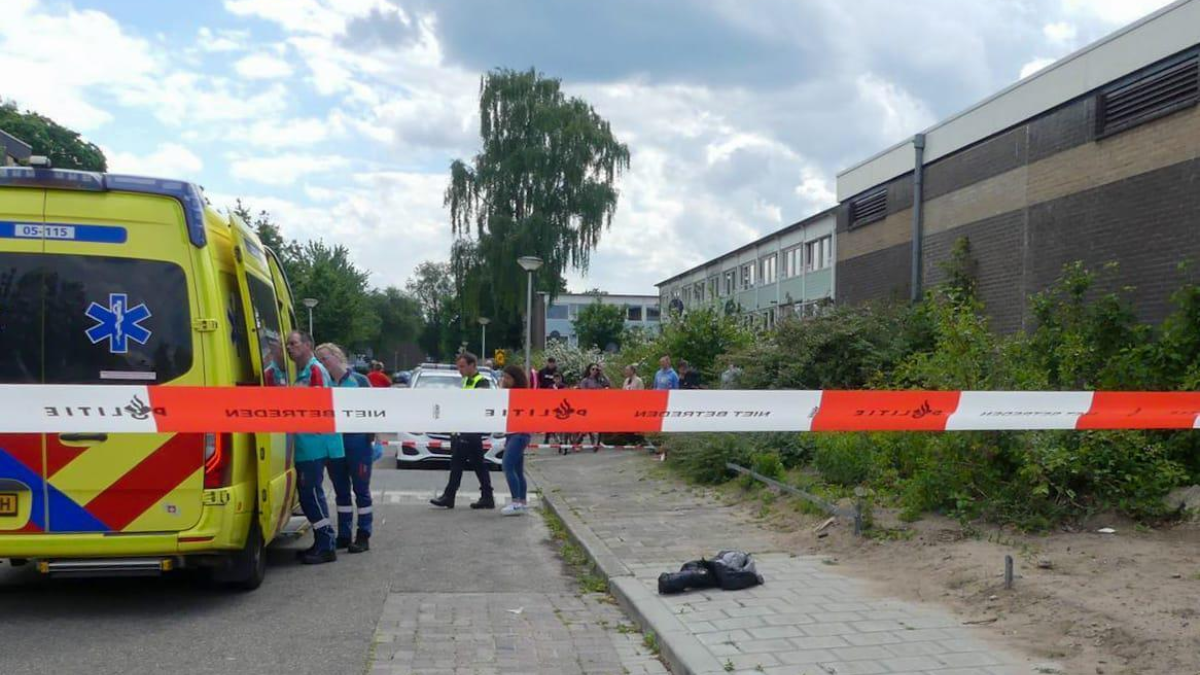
[648,240,1200,530]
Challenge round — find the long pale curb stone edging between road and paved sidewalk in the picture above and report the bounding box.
[526,468,726,675]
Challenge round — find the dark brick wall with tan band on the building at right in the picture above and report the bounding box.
[836,49,1200,331]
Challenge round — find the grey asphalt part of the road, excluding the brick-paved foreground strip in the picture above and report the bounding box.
[0,459,549,675]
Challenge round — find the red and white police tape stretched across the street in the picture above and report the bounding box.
[0,384,1200,434]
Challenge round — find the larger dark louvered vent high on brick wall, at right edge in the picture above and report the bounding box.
[1096,52,1200,137]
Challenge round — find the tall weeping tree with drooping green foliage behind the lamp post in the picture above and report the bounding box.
[445,70,629,345]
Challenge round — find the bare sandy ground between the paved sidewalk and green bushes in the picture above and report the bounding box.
[726,488,1200,675]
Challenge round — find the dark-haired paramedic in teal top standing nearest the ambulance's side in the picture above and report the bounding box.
[287,330,346,565]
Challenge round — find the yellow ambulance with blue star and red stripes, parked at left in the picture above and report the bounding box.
[0,167,300,589]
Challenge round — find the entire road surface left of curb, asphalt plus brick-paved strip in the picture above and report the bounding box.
[0,451,665,675]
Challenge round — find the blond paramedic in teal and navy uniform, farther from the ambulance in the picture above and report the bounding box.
[317,342,374,554]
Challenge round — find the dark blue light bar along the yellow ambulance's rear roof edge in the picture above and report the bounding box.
[0,167,208,249]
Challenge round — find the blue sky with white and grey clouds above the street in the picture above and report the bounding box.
[0,0,1166,293]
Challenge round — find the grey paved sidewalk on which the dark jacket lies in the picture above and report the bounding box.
[530,453,1060,675]
